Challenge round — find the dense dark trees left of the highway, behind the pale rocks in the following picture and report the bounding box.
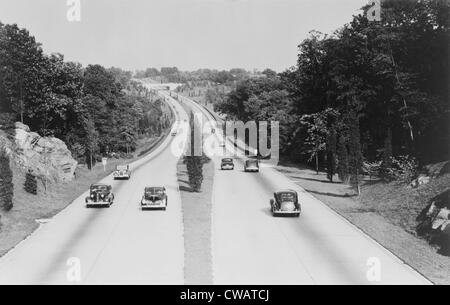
[0,23,172,164]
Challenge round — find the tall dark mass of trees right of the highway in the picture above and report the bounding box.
[216,0,450,181]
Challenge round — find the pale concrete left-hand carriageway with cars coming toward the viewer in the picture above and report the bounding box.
[0,93,187,284]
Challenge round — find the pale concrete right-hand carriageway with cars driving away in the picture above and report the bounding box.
[178,93,430,284]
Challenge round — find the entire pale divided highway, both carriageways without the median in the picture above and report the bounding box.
[0,88,429,284]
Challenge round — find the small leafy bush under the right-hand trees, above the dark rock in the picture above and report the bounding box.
[386,156,419,183]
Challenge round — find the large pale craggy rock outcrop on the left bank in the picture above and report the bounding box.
[13,123,78,182]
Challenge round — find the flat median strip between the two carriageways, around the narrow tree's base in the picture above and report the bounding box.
[177,159,214,285]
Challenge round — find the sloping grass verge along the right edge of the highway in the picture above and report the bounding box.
[277,163,450,285]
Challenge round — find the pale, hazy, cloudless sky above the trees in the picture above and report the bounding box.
[0,0,367,71]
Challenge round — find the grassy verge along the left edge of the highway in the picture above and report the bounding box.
[0,131,168,257]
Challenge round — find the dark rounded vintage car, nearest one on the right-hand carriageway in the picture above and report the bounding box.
[270,190,302,217]
